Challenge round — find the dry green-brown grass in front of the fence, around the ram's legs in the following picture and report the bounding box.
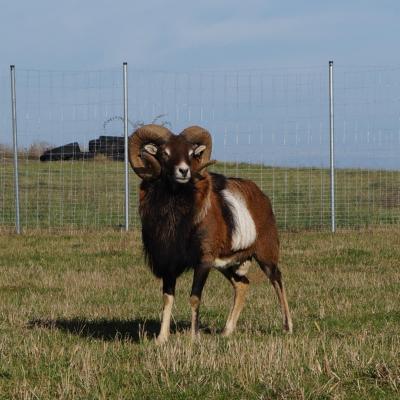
[0,227,400,399]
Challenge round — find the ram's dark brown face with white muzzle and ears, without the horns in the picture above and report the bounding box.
[145,135,205,184]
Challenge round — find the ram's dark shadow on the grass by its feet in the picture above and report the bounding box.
[28,318,210,342]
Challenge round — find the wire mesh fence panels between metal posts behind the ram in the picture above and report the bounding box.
[0,66,400,229]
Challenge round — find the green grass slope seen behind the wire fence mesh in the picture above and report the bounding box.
[0,157,400,230]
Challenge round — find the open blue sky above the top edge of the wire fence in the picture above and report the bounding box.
[0,0,400,70]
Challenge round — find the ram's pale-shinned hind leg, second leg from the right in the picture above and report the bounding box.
[219,261,250,336]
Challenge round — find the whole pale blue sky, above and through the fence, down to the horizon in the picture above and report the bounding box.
[0,0,400,168]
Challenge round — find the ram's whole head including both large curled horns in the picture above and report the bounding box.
[128,124,214,184]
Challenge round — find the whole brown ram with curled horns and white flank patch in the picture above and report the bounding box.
[128,124,292,343]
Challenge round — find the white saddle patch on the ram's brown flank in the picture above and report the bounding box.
[222,189,257,251]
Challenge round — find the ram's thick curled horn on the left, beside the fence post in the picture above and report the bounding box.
[128,124,171,179]
